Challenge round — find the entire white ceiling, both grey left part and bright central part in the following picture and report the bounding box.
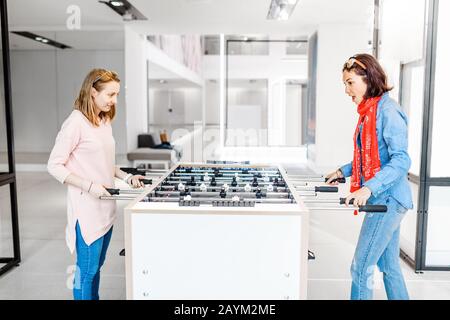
[8,0,373,49]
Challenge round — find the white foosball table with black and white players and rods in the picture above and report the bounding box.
[104,163,385,300]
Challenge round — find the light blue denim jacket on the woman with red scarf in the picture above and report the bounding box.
[340,93,413,209]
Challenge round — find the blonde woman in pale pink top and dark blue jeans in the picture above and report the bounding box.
[47,69,144,300]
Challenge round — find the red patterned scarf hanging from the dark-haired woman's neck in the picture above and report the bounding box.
[350,97,381,192]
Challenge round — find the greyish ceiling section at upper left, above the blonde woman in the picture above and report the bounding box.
[8,0,124,50]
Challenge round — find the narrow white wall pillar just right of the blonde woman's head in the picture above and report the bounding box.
[125,26,148,151]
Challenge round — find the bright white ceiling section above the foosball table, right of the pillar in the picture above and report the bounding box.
[126,0,374,35]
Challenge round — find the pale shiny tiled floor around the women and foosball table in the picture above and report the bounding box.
[0,167,450,299]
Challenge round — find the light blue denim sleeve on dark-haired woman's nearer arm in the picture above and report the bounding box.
[364,108,411,197]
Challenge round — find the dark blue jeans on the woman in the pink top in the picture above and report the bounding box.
[73,221,113,300]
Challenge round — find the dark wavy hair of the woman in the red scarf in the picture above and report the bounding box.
[342,53,393,99]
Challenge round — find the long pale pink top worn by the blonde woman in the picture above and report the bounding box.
[47,110,116,253]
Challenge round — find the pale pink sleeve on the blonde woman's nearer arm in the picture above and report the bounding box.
[47,115,81,183]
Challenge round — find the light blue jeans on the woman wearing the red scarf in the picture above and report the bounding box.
[350,196,409,300]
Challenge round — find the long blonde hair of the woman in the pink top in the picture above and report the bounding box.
[74,69,120,127]
